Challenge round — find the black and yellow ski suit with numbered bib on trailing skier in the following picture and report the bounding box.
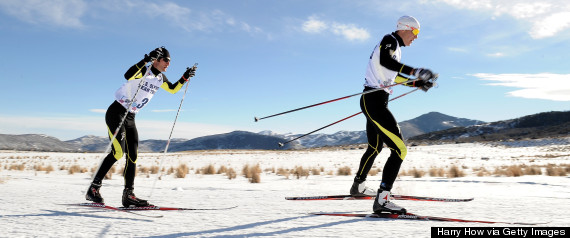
[93,60,185,189]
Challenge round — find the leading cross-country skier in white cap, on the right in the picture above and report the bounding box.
[350,16,435,213]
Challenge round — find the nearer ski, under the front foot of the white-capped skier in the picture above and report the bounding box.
[312,213,546,225]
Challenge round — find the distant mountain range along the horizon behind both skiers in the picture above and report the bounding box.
[0,111,570,152]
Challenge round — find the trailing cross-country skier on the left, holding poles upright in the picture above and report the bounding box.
[85,46,196,207]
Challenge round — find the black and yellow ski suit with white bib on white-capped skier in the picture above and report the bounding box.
[354,32,416,190]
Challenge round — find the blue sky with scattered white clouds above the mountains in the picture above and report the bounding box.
[0,0,570,140]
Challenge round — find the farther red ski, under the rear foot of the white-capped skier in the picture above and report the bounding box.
[285,194,473,202]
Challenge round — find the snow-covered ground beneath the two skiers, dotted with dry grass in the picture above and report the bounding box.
[0,141,570,237]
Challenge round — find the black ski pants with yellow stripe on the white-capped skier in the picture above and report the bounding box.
[354,87,407,190]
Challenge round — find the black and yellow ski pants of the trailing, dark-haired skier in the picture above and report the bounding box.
[93,101,139,188]
